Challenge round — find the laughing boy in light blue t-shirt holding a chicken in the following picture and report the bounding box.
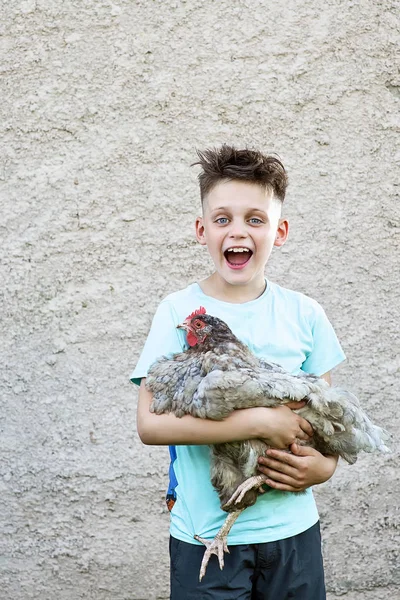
[131,145,344,600]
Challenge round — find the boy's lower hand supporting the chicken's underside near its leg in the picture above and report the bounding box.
[258,444,338,492]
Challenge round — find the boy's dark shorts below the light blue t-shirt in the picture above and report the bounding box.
[170,523,326,600]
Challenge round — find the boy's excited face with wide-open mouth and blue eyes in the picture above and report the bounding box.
[196,180,288,289]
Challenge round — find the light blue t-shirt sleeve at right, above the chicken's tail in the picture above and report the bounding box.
[301,303,346,376]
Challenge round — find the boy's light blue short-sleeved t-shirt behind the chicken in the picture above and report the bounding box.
[131,281,345,544]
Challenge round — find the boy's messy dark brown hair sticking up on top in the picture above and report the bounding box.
[192,144,288,202]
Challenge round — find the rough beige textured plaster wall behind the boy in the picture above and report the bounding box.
[0,0,400,600]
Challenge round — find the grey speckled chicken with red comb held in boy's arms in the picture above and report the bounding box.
[146,307,389,580]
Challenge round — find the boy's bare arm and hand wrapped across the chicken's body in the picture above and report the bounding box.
[137,378,312,448]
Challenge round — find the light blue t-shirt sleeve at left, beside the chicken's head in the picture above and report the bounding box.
[130,300,185,385]
